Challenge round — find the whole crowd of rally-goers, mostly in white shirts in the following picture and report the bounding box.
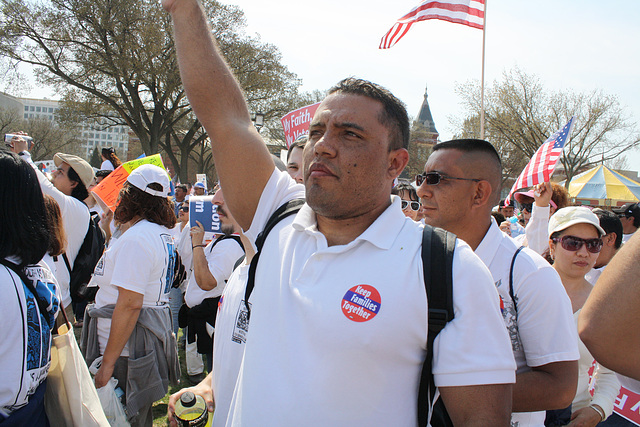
[0,0,640,427]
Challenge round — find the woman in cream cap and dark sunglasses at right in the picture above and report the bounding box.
[548,206,620,426]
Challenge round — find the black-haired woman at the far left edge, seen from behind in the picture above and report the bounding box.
[0,151,59,427]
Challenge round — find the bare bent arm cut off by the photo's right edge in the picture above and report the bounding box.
[578,233,640,380]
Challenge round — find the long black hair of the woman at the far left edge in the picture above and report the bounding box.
[0,151,49,267]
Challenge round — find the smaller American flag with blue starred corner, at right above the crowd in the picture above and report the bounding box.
[507,117,575,204]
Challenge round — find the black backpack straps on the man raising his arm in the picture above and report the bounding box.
[244,199,456,427]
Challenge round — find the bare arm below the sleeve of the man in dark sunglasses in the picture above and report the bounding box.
[513,368,578,412]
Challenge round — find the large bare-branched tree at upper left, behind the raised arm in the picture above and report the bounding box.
[0,0,308,179]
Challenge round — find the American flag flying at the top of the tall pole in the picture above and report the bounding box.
[379,0,484,49]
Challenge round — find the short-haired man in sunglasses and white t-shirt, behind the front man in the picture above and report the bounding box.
[416,139,579,427]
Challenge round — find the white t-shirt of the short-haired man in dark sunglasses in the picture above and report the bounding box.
[476,218,580,427]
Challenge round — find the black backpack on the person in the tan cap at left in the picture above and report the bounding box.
[62,212,105,302]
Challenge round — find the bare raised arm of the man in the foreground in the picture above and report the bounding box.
[163,0,274,230]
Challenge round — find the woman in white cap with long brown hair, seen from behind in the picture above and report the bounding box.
[92,165,176,425]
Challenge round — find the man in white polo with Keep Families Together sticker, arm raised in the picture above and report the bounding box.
[164,0,515,426]
